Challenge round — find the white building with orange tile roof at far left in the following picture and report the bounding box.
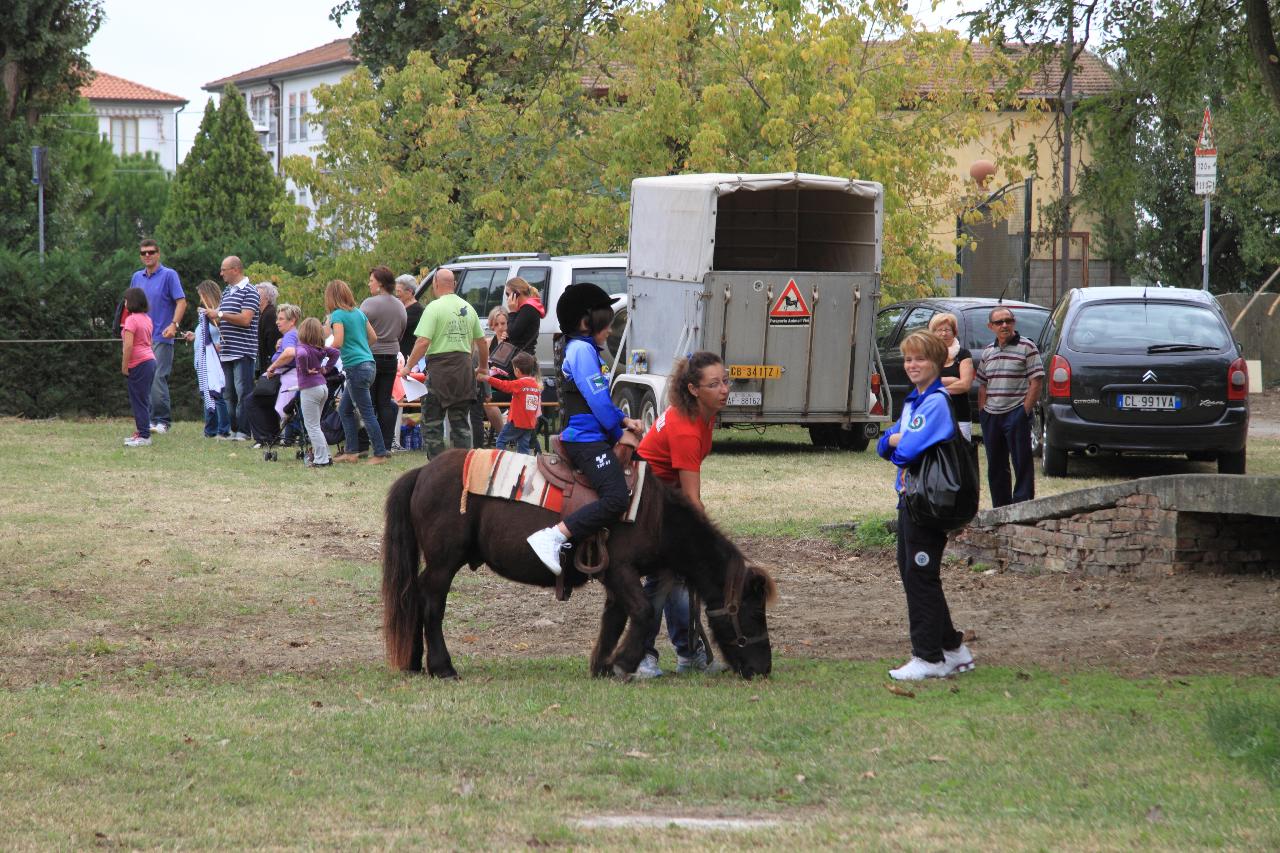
[81,69,187,172]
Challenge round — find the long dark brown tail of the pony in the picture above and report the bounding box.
[383,469,422,670]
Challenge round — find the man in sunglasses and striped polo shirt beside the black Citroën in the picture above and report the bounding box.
[977,305,1044,506]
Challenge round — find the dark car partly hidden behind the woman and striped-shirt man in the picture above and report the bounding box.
[876,296,1048,423]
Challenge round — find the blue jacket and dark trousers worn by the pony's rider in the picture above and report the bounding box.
[561,336,631,542]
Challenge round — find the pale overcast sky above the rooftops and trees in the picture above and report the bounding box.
[88,0,980,163]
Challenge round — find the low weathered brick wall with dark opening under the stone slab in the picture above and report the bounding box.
[951,494,1280,575]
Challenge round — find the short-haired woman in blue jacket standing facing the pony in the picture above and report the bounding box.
[877,332,974,681]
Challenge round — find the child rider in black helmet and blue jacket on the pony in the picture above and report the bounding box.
[529,282,644,575]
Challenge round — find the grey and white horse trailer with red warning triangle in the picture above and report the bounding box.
[612,173,891,450]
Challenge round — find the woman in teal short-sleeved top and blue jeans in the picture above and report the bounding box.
[324,279,390,465]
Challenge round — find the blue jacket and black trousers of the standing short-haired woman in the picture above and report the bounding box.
[876,379,964,663]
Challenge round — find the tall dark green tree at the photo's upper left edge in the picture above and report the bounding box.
[0,0,102,247]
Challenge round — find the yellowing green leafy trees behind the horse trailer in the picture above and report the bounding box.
[288,0,1016,295]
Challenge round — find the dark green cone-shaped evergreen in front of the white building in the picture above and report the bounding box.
[156,83,284,247]
